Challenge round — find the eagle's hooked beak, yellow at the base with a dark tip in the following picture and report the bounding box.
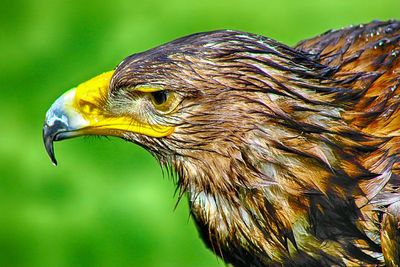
[43,71,174,165]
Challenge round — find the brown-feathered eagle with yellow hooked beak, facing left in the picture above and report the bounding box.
[43,20,400,267]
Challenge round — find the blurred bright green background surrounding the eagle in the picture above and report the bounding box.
[0,0,400,267]
